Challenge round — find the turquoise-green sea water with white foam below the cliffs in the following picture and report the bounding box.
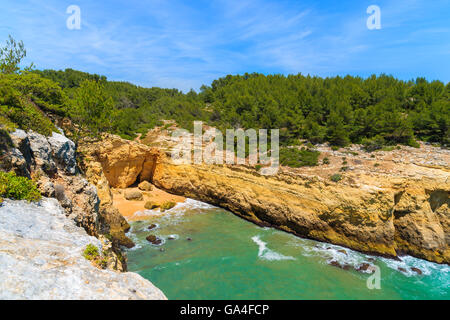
[128,199,450,299]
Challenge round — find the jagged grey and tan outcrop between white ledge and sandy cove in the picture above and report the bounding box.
[5,130,132,271]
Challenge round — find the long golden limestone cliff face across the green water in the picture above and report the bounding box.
[82,137,450,263]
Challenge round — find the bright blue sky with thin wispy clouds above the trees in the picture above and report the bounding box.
[0,0,450,92]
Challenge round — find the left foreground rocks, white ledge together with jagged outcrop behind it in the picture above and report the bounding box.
[0,129,166,299]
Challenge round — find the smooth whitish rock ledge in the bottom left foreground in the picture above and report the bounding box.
[0,199,167,300]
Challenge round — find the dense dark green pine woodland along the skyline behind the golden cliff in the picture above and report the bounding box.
[36,69,450,150]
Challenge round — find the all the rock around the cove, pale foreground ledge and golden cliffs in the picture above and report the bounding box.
[0,125,450,299]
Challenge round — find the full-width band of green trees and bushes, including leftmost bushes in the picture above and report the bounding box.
[0,35,450,163]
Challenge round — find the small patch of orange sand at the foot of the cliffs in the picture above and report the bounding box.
[111,186,186,221]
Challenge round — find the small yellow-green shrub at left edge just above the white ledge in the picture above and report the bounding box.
[0,171,41,201]
